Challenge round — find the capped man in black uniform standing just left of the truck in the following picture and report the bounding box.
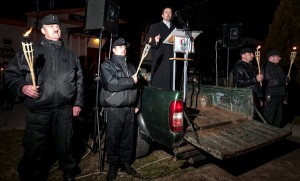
[100,38,141,180]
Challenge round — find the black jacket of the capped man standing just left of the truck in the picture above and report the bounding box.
[100,55,141,108]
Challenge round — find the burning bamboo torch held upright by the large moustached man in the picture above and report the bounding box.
[22,27,36,87]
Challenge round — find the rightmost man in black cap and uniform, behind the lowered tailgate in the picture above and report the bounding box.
[262,50,290,127]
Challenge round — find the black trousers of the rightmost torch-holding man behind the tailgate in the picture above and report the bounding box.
[264,96,284,127]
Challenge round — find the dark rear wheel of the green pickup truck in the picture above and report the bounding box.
[135,128,150,158]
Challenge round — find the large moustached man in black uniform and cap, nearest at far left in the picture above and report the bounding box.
[5,14,84,181]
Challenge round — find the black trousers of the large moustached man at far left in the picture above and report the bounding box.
[18,106,76,181]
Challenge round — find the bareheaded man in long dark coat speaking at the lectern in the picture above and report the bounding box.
[145,7,175,90]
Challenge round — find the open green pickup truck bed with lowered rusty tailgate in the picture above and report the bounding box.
[138,85,292,160]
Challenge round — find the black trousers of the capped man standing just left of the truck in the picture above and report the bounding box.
[105,107,134,165]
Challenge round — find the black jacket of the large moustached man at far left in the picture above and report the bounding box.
[5,38,84,111]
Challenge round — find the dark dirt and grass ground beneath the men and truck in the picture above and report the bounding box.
[0,131,300,181]
